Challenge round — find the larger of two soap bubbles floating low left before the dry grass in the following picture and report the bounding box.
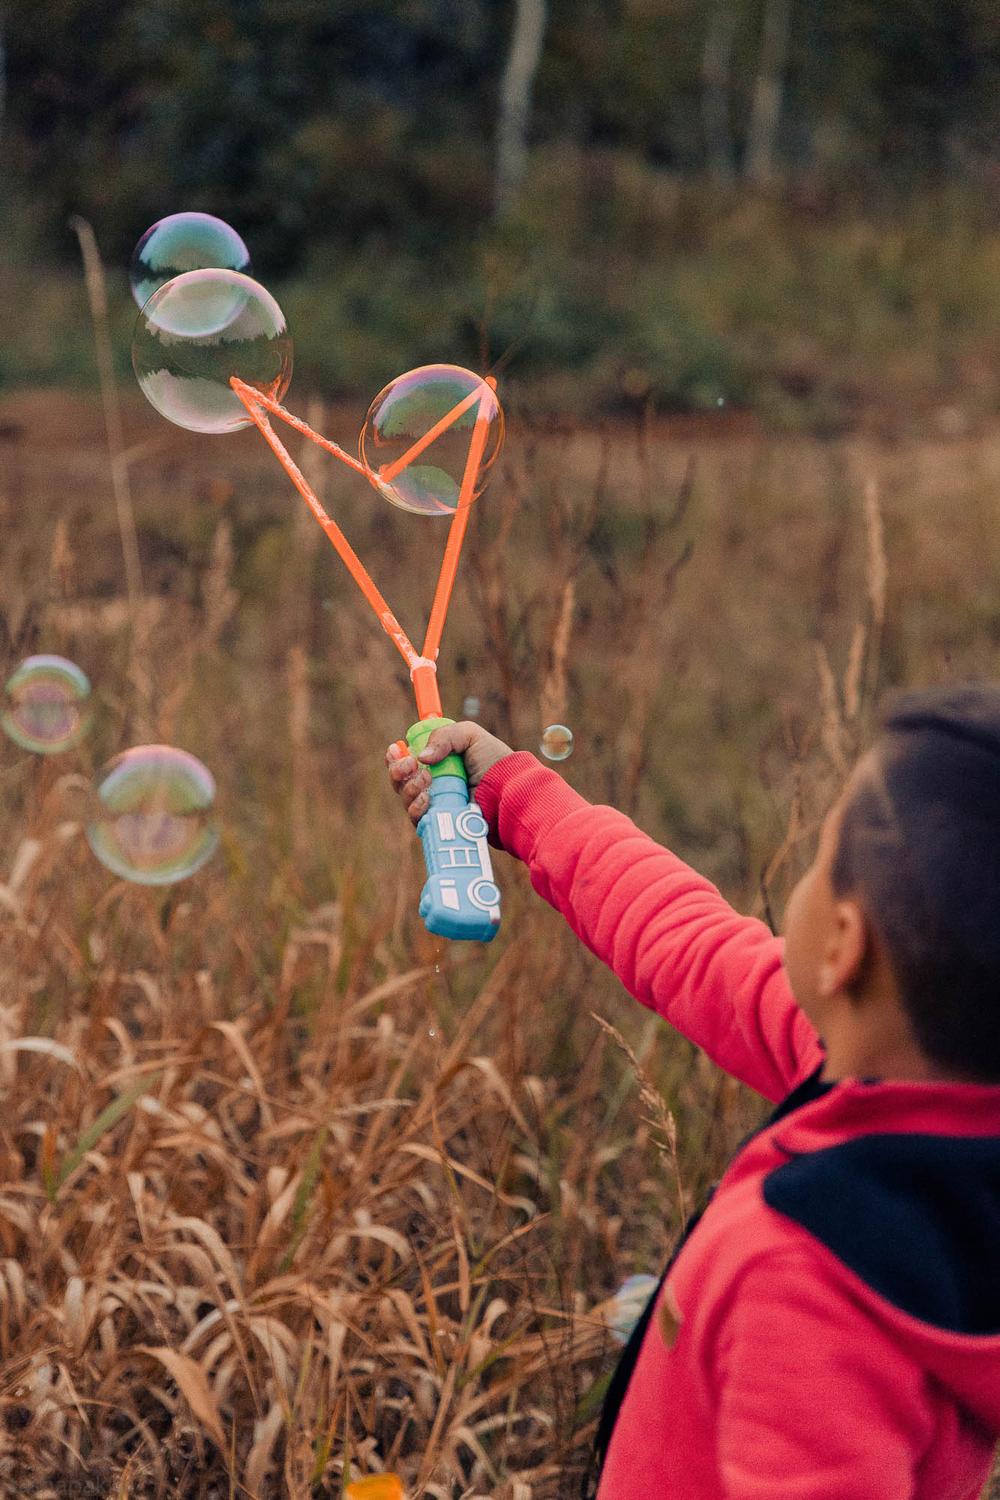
[87,746,219,885]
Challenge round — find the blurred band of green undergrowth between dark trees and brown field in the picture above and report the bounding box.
[0,183,1000,429]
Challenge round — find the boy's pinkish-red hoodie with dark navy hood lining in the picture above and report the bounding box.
[475,752,1000,1500]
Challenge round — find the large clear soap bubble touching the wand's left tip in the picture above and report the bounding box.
[132,270,292,432]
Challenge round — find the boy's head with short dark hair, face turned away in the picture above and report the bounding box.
[786,687,1000,1083]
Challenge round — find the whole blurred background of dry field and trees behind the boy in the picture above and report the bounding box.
[0,0,1000,1500]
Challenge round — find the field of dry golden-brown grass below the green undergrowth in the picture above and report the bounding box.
[0,395,1000,1500]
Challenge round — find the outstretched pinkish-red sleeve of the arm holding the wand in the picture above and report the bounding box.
[475,752,822,1100]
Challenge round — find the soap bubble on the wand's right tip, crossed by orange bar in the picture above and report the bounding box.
[358,365,504,516]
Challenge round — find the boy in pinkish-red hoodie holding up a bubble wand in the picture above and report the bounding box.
[387,687,1000,1500]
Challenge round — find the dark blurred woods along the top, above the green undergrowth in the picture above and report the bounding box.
[3,0,1000,270]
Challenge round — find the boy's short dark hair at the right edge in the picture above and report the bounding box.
[831,686,1000,1083]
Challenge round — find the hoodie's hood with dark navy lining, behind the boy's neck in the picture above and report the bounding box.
[743,1070,1000,1433]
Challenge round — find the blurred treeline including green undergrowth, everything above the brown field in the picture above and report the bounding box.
[0,0,1000,429]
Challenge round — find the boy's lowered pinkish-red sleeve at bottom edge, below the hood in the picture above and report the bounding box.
[711,1251,934,1500]
